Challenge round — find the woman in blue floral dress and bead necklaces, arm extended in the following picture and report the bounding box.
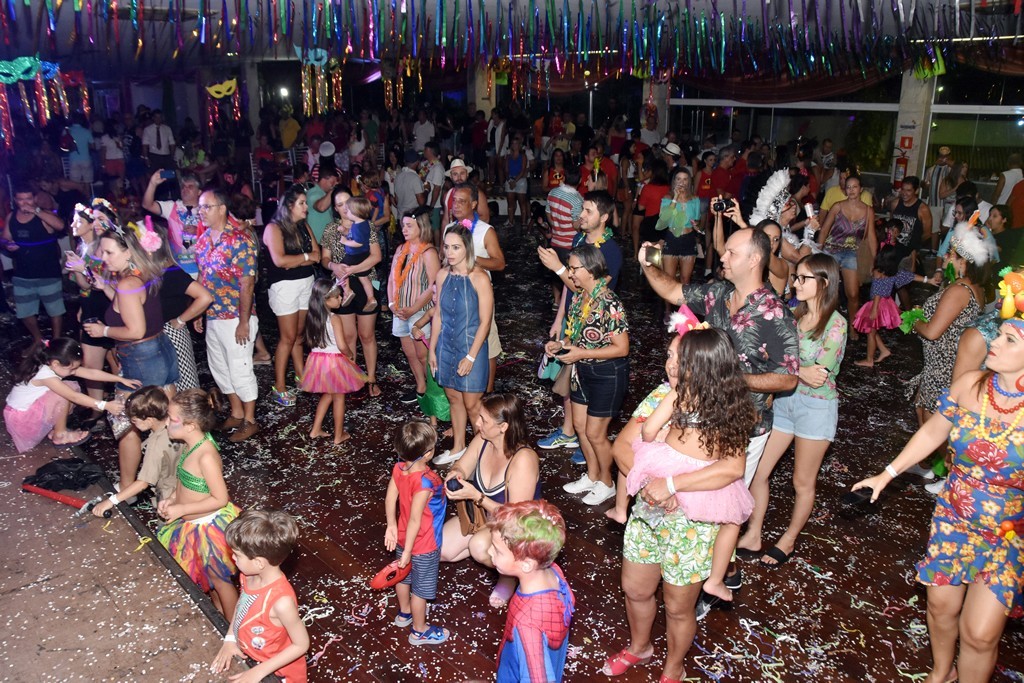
[853,318,1024,683]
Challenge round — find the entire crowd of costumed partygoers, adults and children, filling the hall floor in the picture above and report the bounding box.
[0,100,1024,683]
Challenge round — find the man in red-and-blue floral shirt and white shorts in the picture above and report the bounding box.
[196,189,259,442]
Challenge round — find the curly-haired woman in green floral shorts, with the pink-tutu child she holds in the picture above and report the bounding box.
[602,327,757,683]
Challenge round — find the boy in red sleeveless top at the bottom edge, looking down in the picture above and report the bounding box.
[210,510,309,683]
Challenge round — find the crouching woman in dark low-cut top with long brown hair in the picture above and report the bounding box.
[441,393,541,607]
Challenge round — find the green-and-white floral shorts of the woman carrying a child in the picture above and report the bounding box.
[623,499,719,586]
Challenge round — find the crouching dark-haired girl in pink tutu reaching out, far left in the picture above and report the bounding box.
[3,337,141,453]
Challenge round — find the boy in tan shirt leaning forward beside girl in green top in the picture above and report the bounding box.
[92,386,181,517]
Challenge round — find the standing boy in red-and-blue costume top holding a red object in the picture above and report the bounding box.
[384,420,451,645]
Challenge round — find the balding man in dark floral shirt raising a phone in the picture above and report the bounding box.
[639,228,800,618]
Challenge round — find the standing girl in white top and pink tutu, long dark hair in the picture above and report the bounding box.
[302,278,367,443]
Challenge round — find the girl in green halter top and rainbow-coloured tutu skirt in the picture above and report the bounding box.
[157,389,239,616]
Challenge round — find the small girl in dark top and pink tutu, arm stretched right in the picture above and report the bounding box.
[853,246,928,368]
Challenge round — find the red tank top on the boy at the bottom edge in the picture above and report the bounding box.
[231,574,306,683]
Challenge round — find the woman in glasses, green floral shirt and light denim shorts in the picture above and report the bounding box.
[736,254,843,567]
